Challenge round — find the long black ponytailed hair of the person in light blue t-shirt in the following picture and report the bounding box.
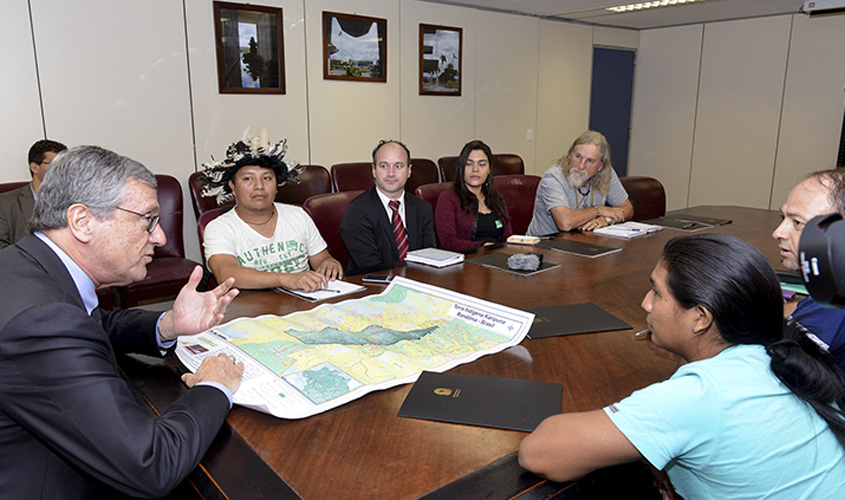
[662,234,845,447]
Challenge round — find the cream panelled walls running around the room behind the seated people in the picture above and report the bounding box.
[8,0,845,259]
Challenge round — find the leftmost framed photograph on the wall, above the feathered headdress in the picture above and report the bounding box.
[214,2,285,94]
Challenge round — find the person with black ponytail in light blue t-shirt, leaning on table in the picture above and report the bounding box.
[519,234,845,500]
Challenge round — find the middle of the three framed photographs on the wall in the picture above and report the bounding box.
[323,12,387,83]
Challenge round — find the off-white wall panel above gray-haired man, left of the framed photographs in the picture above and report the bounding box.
[28,0,199,258]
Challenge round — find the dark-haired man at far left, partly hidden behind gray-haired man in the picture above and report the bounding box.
[0,139,67,248]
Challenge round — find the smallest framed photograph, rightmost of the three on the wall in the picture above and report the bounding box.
[420,24,463,96]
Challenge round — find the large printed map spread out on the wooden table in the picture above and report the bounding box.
[176,277,534,418]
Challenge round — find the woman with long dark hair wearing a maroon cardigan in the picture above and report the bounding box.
[434,140,513,251]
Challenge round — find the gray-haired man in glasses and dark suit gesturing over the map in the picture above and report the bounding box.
[0,146,243,499]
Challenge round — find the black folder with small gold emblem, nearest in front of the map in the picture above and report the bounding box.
[399,372,563,432]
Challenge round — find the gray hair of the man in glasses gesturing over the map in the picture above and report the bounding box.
[29,146,158,232]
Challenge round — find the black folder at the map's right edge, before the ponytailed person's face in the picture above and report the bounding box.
[528,302,633,339]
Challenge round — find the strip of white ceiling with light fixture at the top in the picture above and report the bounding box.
[418,0,804,29]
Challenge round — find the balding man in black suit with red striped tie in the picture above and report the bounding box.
[340,141,435,276]
